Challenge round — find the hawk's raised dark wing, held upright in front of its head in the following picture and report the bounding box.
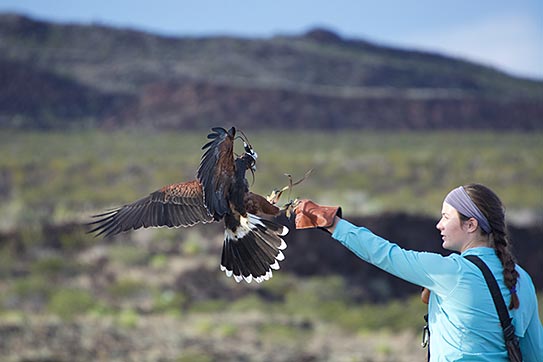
[198,127,236,220]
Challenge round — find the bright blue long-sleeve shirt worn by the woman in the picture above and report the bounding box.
[332,220,543,362]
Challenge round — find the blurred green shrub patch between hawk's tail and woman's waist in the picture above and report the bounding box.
[217,274,427,333]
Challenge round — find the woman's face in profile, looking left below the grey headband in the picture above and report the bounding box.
[436,202,469,252]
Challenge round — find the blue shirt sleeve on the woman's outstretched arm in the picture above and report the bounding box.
[332,219,461,296]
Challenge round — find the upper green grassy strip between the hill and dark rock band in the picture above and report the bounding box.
[0,131,543,228]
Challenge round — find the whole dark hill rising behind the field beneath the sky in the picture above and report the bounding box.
[0,14,543,130]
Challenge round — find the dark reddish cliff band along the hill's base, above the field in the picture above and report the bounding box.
[114,81,543,130]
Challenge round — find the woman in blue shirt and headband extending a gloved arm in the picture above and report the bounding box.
[295,184,543,362]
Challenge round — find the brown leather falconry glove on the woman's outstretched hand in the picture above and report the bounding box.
[294,200,341,229]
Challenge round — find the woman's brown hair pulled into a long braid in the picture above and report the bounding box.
[460,184,520,309]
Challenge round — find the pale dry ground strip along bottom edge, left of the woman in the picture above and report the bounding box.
[0,313,425,362]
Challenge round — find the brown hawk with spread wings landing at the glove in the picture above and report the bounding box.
[89,127,289,283]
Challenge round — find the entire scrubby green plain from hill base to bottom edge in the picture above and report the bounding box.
[0,131,543,361]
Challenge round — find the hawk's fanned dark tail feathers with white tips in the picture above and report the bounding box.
[221,214,288,283]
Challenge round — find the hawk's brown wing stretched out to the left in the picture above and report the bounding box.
[89,180,213,236]
